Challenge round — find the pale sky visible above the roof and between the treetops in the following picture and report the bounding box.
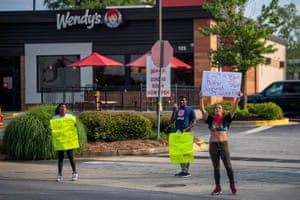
[0,0,300,14]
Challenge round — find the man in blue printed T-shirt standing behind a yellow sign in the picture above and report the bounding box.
[171,96,196,177]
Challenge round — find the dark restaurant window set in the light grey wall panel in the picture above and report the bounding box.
[37,55,80,92]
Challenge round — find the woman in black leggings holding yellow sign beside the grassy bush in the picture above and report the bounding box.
[50,103,79,181]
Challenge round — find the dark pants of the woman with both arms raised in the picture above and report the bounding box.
[209,141,234,185]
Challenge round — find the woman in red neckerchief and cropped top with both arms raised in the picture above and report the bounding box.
[199,92,243,195]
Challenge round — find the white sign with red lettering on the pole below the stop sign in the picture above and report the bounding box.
[146,56,171,97]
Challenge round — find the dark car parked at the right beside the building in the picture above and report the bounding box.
[241,80,300,117]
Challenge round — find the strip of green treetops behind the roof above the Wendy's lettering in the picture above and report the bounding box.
[44,0,154,10]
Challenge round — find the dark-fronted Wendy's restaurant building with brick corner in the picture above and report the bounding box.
[0,0,286,111]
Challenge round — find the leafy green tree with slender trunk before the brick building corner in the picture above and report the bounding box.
[199,0,282,109]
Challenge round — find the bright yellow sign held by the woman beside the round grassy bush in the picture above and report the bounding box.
[50,116,79,151]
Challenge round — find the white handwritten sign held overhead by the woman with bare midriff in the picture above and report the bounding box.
[201,71,242,97]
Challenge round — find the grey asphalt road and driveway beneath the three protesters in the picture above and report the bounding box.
[0,112,300,200]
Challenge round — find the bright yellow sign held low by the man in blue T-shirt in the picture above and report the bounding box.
[169,132,194,164]
